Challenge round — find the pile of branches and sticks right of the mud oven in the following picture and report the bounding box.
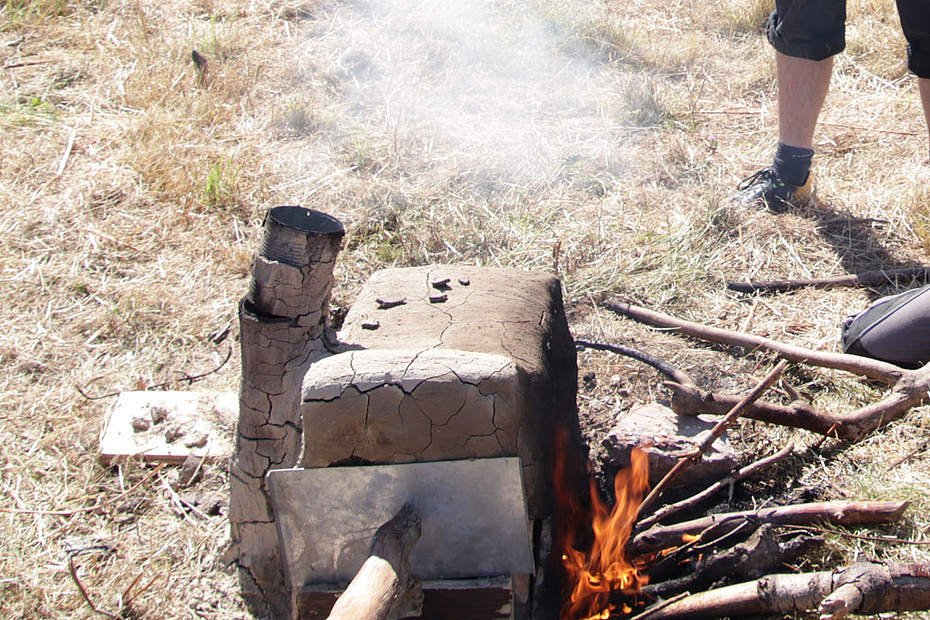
[578,302,930,620]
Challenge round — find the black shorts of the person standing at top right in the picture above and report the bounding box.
[766,0,930,78]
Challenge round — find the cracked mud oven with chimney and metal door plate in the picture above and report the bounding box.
[230,207,580,619]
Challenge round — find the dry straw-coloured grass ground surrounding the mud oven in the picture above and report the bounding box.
[0,0,930,618]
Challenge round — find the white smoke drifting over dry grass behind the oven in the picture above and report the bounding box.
[300,0,636,188]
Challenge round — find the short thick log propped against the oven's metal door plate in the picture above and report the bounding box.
[328,504,423,620]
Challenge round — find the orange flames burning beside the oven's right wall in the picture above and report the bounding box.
[556,438,649,620]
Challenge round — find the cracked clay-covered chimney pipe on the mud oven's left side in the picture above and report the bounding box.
[229,207,345,617]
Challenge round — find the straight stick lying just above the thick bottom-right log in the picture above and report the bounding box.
[627,501,910,557]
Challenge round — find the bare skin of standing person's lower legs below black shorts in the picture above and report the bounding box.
[775,52,832,149]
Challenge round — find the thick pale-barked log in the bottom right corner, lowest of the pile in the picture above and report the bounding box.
[648,562,930,620]
